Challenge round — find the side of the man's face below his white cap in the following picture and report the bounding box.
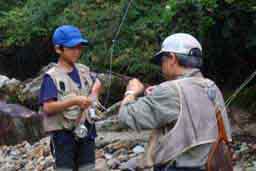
[161,53,176,80]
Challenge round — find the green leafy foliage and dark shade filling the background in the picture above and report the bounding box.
[0,0,256,109]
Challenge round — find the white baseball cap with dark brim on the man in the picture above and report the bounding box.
[153,33,202,64]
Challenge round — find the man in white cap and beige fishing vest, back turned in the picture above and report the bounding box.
[119,33,231,171]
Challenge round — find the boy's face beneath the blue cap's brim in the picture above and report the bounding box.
[56,44,83,63]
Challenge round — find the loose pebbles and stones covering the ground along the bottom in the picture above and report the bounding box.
[0,132,256,171]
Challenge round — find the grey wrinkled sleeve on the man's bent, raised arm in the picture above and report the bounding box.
[119,82,180,130]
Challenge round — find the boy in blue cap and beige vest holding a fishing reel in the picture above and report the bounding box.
[39,25,101,171]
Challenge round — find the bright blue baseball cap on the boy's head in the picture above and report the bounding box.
[52,25,88,48]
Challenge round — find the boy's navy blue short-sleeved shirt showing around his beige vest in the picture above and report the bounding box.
[39,67,97,139]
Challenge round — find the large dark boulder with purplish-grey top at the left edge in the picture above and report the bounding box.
[0,102,43,145]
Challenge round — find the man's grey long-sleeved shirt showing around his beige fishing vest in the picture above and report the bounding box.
[119,69,231,167]
